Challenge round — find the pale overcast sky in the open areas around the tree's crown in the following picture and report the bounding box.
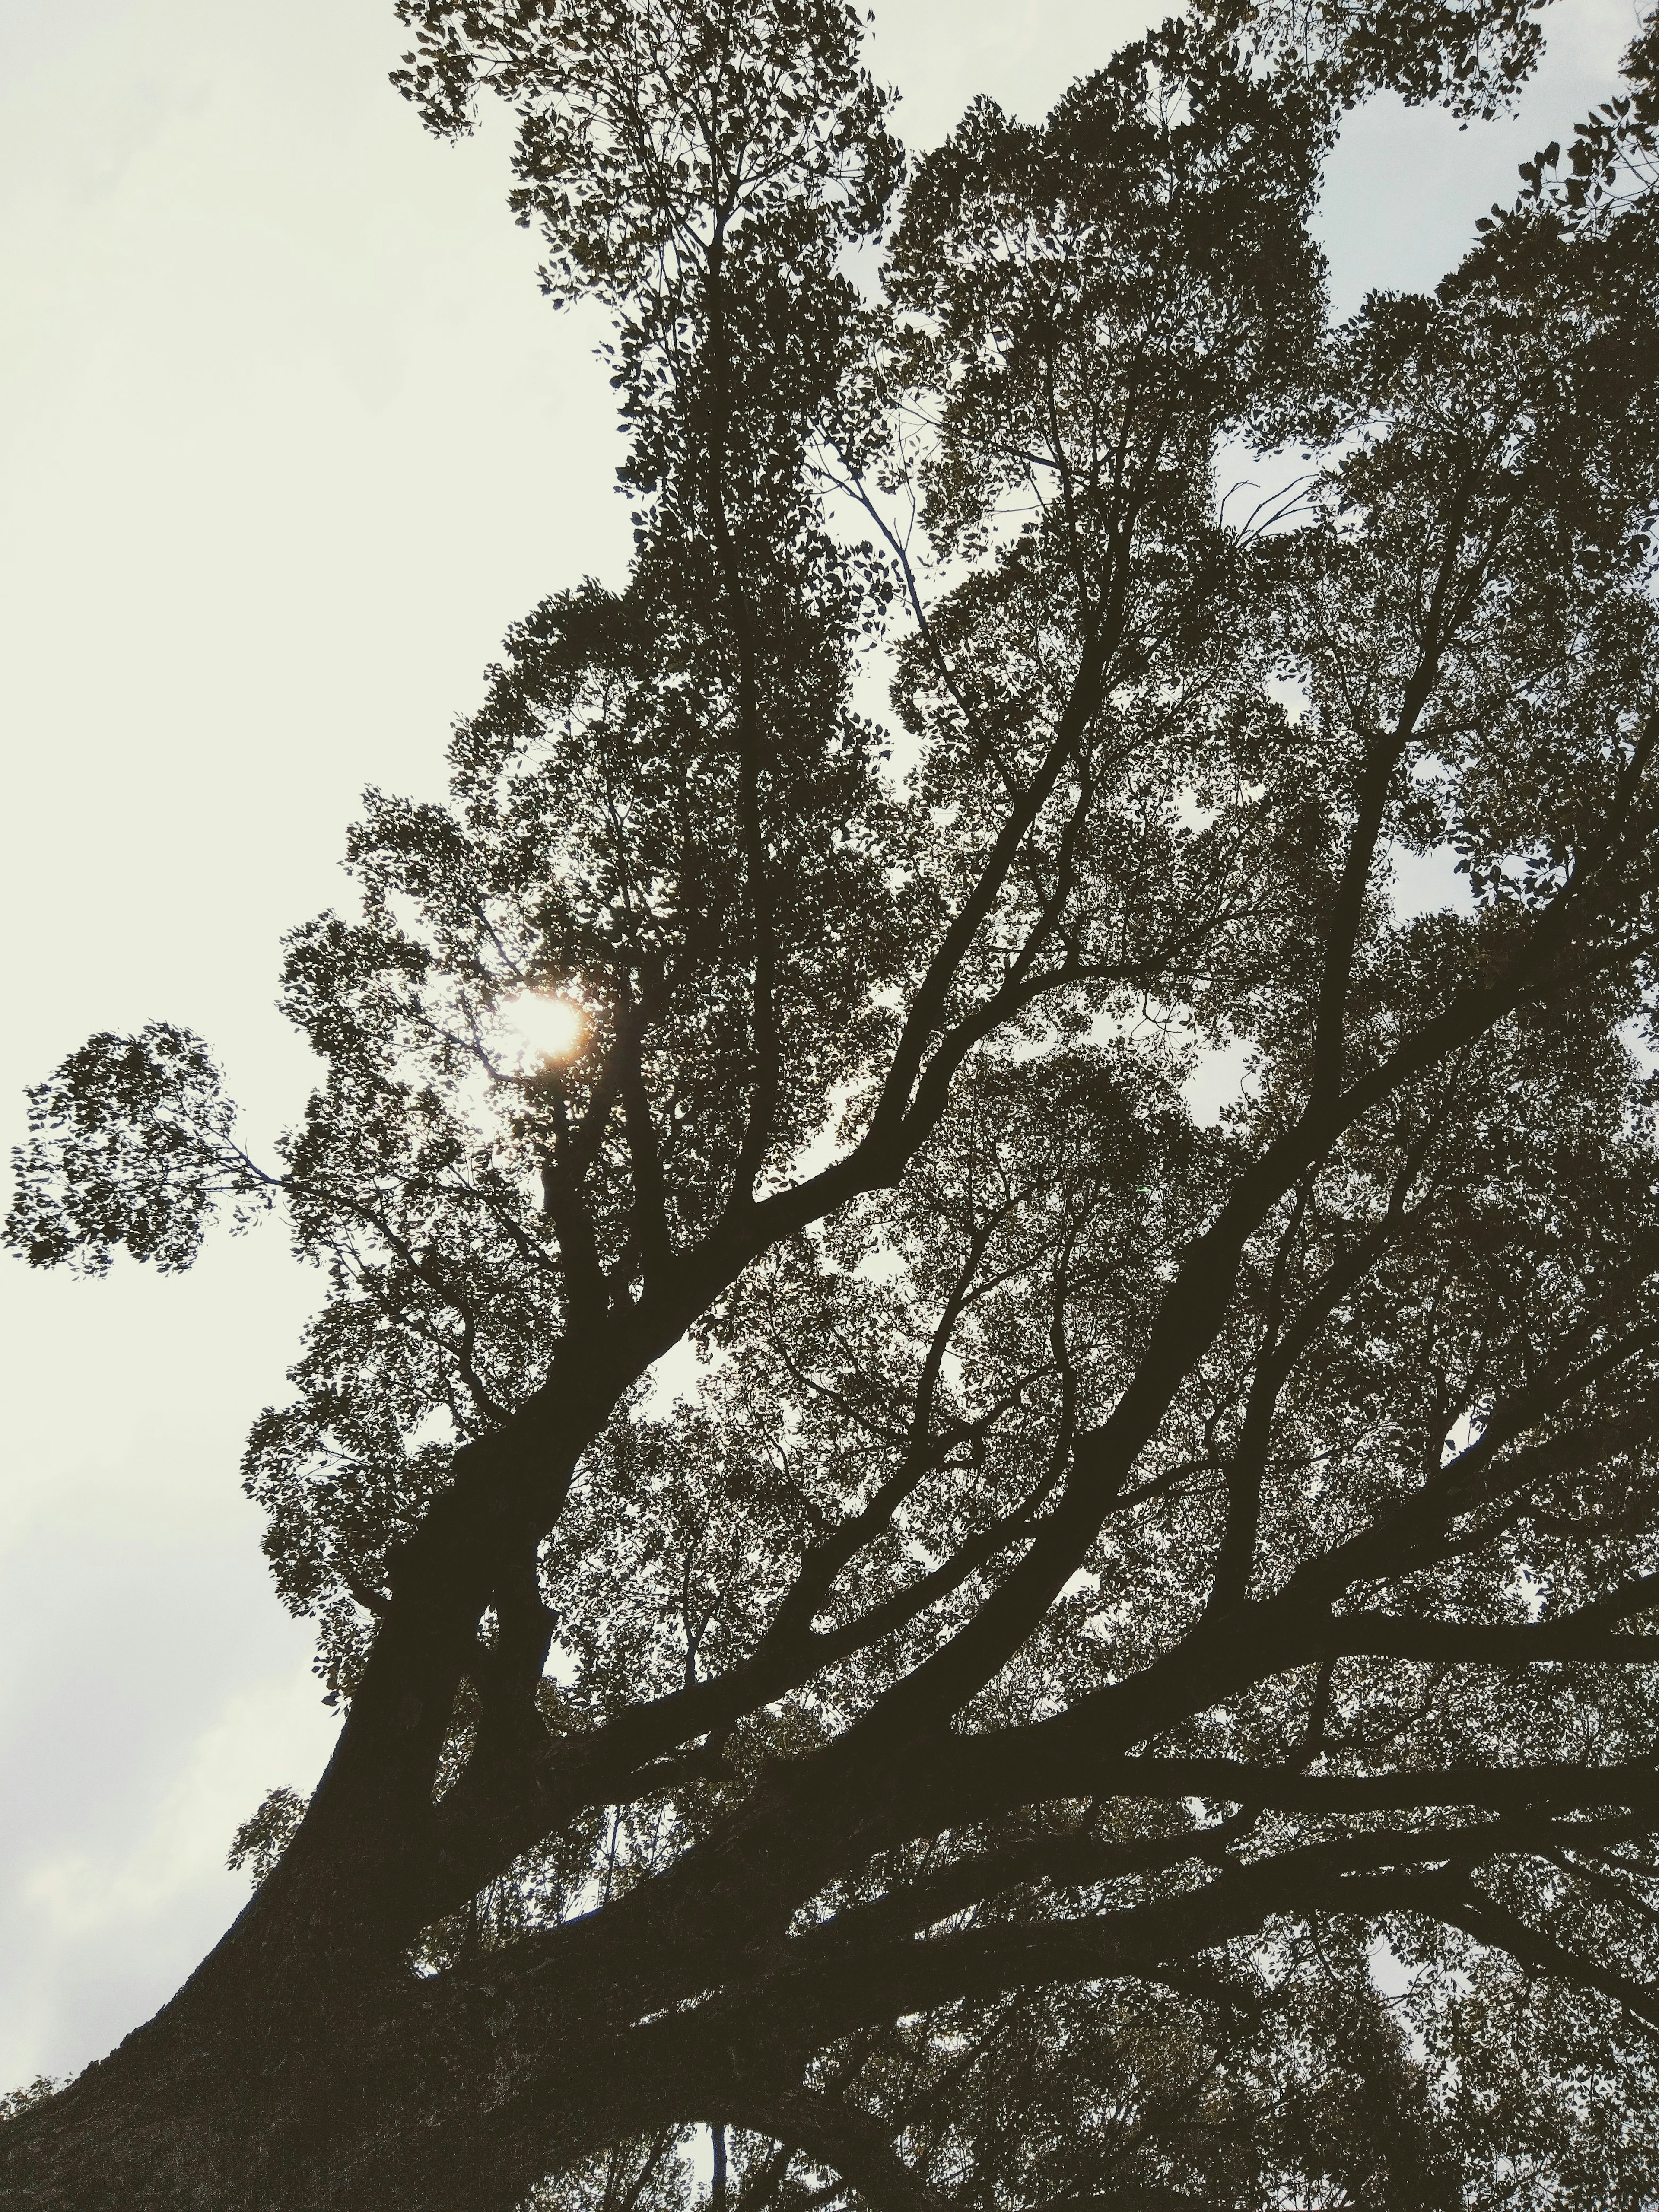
[0,0,1635,2090]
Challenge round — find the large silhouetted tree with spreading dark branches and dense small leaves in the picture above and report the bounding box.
[0,0,1659,2212]
